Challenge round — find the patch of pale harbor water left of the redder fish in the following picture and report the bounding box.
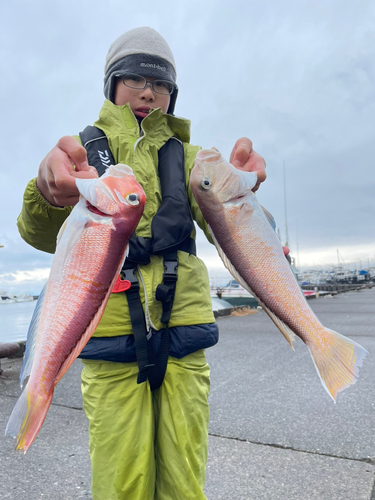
[0,300,36,342]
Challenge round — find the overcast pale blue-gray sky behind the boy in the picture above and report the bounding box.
[0,0,375,293]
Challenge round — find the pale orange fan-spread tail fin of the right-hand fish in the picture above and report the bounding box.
[308,327,368,401]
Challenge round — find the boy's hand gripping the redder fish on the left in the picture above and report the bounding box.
[36,136,98,207]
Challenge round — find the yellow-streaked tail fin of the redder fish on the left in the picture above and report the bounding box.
[5,386,53,453]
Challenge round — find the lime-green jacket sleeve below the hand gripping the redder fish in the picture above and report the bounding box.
[17,179,72,253]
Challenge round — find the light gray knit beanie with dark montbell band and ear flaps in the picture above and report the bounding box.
[104,27,178,115]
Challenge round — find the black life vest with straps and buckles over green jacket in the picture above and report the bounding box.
[79,126,196,390]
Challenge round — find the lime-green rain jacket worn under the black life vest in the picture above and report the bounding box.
[17,101,215,337]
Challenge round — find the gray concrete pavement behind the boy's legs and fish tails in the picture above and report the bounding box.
[0,288,375,500]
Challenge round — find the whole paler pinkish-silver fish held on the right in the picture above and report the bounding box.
[190,150,367,400]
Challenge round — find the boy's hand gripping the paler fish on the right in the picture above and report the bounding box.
[229,137,267,191]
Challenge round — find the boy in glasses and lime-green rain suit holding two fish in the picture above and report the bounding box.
[18,28,266,500]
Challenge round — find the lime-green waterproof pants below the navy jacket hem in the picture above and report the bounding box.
[82,350,210,500]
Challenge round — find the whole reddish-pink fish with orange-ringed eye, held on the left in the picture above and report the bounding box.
[5,165,146,452]
